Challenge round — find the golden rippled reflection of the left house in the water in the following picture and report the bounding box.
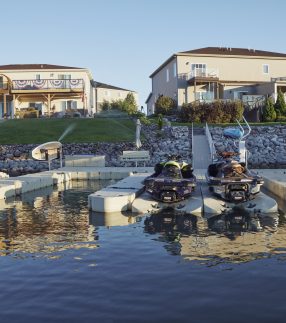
[0,181,111,255]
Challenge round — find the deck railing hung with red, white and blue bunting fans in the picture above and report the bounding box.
[12,79,84,91]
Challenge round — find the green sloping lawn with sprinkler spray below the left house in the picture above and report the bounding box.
[0,118,136,144]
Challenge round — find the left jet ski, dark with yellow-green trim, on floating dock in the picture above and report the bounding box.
[144,155,196,203]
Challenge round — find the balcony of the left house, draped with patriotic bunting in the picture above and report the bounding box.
[11,79,84,93]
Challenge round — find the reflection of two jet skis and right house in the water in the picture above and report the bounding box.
[145,208,286,265]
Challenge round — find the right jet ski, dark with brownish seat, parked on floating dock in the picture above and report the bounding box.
[206,152,264,203]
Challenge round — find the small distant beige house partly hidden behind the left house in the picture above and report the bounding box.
[92,81,139,113]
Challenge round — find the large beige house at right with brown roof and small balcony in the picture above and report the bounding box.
[146,47,286,115]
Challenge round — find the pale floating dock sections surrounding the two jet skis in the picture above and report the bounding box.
[0,166,286,216]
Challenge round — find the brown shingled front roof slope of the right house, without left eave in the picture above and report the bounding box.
[178,47,286,57]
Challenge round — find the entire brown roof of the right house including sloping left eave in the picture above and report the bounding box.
[150,47,286,77]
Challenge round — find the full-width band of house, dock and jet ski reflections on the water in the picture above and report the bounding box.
[0,181,286,265]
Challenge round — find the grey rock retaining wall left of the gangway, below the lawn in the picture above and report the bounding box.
[0,125,191,176]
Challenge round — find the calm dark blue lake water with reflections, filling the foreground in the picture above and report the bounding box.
[0,182,286,323]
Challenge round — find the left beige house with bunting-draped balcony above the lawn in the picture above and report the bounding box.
[0,64,95,118]
